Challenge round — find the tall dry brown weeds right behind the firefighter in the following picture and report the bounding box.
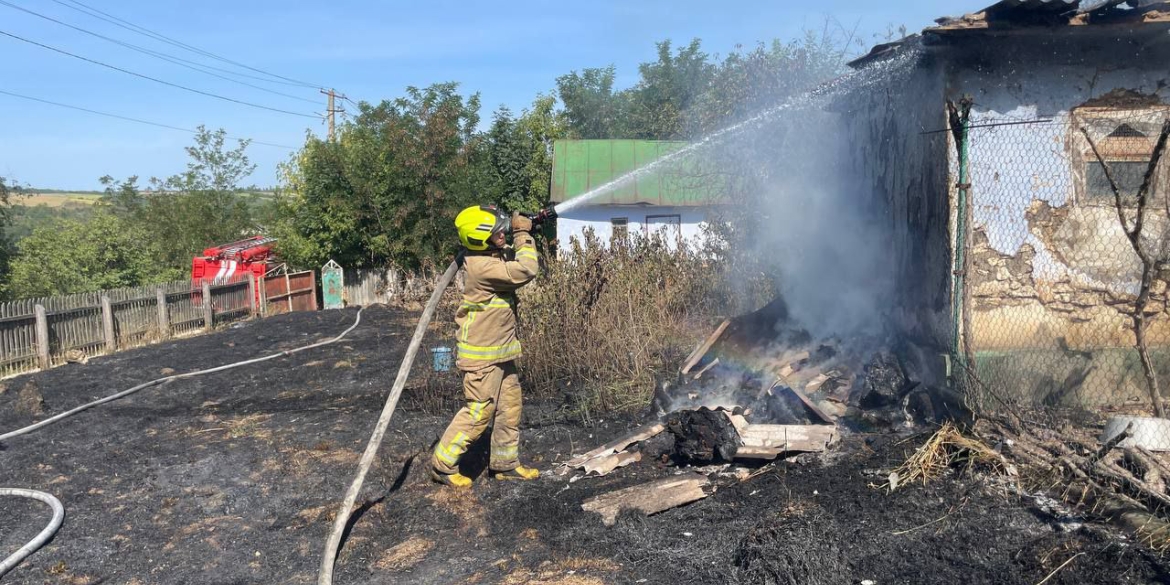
[519,236,753,418]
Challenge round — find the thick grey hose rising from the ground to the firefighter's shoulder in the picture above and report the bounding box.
[317,259,462,585]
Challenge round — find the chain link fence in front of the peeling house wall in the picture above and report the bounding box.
[957,106,1170,418]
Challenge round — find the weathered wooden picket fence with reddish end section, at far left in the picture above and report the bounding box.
[0,271,317,378]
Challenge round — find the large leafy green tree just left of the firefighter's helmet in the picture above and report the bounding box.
[275,83,489,268]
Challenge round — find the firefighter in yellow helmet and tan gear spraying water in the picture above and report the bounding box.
[432,206,541,488]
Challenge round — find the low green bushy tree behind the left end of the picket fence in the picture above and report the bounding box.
[8,211,164,298]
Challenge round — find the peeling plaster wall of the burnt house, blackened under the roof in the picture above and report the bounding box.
[945,33,1170,351]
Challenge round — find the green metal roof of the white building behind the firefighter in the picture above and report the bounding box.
[550,139,721,206]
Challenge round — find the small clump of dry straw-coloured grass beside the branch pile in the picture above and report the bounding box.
[875,422,1007,491]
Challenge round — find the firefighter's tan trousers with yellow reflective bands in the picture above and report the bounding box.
[432,362,521,474]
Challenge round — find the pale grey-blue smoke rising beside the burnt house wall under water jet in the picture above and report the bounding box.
[710,47,917,339]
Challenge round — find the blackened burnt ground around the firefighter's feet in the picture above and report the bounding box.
[0,308,1170,585]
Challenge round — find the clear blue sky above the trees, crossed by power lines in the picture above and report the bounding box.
[0,0,968,190]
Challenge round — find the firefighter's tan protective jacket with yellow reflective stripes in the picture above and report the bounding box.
[455,232,541,372]
